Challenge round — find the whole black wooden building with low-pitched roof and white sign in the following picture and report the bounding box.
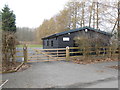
[42,26,111,49]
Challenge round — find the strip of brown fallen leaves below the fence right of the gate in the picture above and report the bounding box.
[71,58,118,64]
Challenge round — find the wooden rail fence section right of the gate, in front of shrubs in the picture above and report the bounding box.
[69,46,119,57]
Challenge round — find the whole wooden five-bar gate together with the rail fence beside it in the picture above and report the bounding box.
[16,45,119,63]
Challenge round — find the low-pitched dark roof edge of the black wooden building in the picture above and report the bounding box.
[42,26,112,39]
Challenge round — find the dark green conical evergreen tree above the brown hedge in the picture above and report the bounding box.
[2,5,16,32]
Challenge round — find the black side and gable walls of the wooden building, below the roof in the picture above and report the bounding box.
[43,30,110,49]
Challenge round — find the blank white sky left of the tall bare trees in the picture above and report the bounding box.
[0,0,69,28]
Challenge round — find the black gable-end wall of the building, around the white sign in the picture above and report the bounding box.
[58,30,110,48]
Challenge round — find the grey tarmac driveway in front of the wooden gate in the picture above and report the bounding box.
[2,61,118,88]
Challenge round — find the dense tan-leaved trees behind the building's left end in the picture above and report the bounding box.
[36,9,70,43]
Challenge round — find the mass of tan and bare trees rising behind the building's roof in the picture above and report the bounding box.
[36,0,117,43]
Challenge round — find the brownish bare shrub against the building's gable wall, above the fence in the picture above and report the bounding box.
[74,34,109,47]
